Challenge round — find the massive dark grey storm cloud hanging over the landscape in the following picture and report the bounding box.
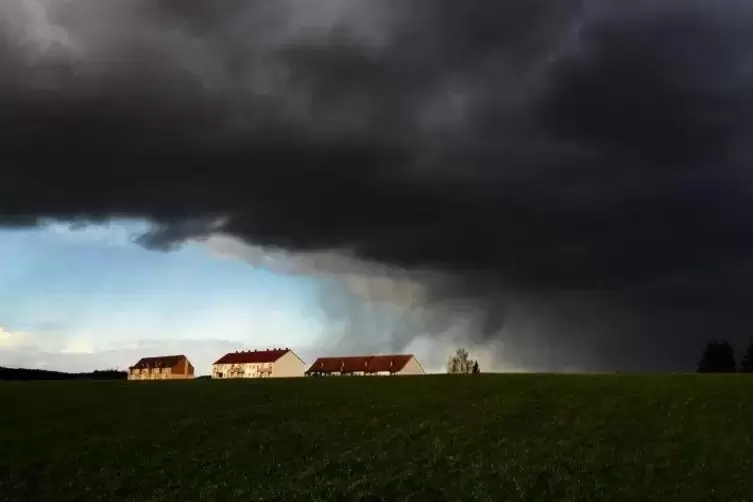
[0,0,753,367]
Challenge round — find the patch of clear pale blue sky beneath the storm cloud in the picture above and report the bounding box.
[0,222,323,372]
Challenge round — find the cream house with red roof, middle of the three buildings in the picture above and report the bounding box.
[212,348,306,379]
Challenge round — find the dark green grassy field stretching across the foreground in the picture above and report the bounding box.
[0,375,753,502]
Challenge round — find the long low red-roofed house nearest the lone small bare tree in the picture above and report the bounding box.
[306,354,425,376]
